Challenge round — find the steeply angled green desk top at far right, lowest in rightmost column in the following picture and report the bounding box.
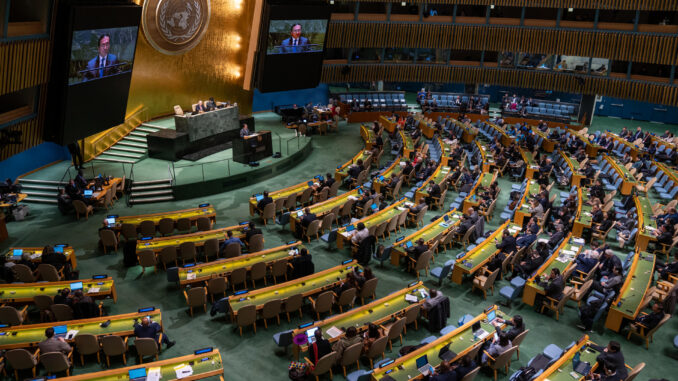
[610,251,656,319]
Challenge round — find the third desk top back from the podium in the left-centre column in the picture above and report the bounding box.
[179,242,304,284]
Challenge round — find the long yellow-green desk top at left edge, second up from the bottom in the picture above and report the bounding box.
[0,310,162,349]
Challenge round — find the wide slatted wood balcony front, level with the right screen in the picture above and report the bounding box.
[327,21,678,65]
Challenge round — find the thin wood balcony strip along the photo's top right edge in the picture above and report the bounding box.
[348,0,678,11]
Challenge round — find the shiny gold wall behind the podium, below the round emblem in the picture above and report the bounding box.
[127,0,259,118]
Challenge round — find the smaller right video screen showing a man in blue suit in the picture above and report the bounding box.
[266,20,327,54]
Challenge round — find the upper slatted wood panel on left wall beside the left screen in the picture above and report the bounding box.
[0,40,52,95]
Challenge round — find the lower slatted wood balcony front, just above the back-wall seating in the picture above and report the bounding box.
[321,64,678,106]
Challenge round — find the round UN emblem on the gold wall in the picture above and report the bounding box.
[141,0,210,55]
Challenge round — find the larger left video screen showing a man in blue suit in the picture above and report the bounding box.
[68,26,139,85]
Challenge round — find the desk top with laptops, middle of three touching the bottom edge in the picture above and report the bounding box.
[373,311,503,381]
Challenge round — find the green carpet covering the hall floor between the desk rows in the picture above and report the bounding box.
[1,108,678,381]
